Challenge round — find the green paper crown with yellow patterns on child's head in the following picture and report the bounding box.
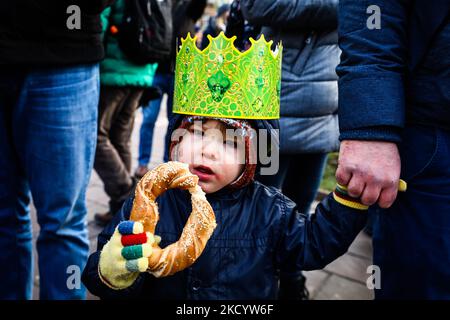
[173,32,282,119]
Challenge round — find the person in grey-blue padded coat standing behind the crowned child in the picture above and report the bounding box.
[240,0,340,299]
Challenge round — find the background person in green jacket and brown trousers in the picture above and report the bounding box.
[94,0,157,225]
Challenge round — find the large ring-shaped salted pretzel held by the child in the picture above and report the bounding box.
[130,161,217,277]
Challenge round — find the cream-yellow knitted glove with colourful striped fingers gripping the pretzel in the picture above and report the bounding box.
[98,221,155,290]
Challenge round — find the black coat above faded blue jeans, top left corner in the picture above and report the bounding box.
[0,0,114,66]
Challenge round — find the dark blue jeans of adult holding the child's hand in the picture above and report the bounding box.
[373,126,450,299]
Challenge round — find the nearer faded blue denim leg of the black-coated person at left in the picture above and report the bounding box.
[14,65,99,299]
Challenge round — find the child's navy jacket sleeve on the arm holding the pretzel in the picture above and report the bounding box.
[81,198,145,299]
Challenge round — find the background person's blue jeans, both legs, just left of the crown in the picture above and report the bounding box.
[138,73,174,166]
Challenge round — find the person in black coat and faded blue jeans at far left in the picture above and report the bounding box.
[0,0,113,300]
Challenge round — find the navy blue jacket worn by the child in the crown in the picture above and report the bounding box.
[82,182,366,300]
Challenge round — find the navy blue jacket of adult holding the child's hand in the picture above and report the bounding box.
[337,0,450,142]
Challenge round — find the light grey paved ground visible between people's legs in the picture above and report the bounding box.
[32,97,373,300]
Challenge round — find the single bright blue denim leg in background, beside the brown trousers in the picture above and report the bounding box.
[138,95,162,166]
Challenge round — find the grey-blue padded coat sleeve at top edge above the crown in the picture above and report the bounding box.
[241,0,338,30]
